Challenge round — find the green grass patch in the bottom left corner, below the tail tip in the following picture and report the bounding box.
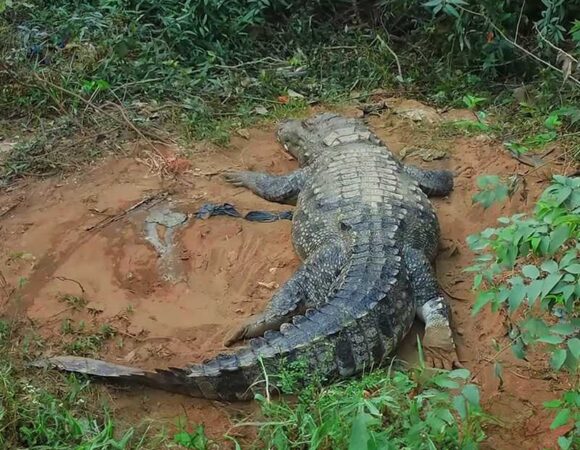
[0,320,169,450]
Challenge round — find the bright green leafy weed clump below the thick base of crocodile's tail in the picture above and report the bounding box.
[257,364,485,450]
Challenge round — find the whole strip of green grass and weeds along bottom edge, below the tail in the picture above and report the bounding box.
[0,314,488,450]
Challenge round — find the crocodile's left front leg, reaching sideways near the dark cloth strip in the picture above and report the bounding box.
[224,169,306,204]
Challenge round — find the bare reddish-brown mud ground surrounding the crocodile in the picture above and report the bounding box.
[0,101,566,449]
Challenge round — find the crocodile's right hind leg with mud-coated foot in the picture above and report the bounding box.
[404,247,460,370]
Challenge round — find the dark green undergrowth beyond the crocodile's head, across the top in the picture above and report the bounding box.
[0,0,580,182]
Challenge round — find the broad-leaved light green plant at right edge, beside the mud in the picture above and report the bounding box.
[467,176,580,449]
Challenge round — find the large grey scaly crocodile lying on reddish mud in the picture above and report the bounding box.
[35,113,459,400]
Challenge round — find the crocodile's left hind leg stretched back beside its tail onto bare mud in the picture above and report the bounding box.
[225,240,347,346]
